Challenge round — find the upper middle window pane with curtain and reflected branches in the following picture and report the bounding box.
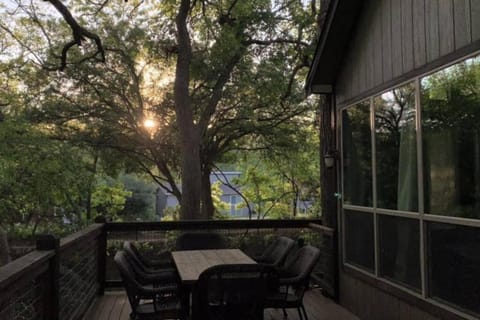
[373,83,418,211]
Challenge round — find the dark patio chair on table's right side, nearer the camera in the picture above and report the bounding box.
[265,245,320,320]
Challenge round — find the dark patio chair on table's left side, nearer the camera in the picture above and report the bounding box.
[114,251,185,320]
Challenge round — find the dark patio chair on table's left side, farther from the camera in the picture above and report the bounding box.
[123,241,179,286]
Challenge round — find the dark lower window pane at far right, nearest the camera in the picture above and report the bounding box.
[427,223,480,316]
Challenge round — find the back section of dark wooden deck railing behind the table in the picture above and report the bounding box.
[105,220,337,298]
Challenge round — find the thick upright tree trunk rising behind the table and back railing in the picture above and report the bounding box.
[174,0,201,220]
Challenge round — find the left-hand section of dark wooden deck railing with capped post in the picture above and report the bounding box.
[0,223,105,320]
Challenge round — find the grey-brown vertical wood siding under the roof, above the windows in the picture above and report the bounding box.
[335,0,480,107]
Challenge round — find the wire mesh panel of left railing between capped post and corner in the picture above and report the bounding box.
[59,239,99,320]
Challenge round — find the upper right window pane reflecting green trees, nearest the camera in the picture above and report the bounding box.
[421,56,480,219]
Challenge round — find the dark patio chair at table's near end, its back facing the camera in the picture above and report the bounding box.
[192,264,273,320]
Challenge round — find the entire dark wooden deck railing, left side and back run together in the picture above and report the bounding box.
[0,219,337,320]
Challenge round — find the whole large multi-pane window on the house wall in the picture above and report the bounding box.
[342,56,480,317]
